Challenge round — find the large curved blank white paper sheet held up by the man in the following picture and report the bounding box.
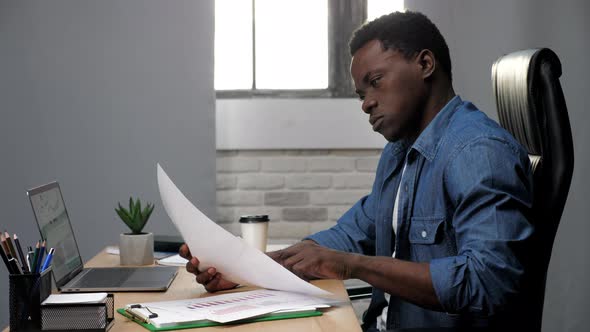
[158,164,331,296]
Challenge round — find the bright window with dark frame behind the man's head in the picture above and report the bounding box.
[215,0,403,98]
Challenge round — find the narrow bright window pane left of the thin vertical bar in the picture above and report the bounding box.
[215,0,253,90]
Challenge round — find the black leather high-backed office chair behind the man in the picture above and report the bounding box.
[492,48,574,331]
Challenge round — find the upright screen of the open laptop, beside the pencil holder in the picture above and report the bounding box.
[27,182,83,286]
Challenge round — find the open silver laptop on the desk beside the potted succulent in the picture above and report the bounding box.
[27,182,178,292]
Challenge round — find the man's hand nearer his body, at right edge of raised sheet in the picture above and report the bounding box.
[267,240,359,280]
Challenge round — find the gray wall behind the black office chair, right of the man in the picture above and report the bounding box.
[406,0,590,332]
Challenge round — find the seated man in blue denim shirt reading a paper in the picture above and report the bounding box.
[181,12,533,330]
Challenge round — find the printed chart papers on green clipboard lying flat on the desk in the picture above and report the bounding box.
[125,289,336,328]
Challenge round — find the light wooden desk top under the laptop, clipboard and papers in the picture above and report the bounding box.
[12,251,361,332]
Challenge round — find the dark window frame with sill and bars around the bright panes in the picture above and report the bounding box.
[215,0,367,99]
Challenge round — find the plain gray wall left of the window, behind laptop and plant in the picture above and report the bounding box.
[0,0,215,327]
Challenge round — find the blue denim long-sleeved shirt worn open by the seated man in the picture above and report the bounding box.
[308,96,533,328]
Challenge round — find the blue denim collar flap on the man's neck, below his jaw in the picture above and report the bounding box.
[412,96,463,161]
